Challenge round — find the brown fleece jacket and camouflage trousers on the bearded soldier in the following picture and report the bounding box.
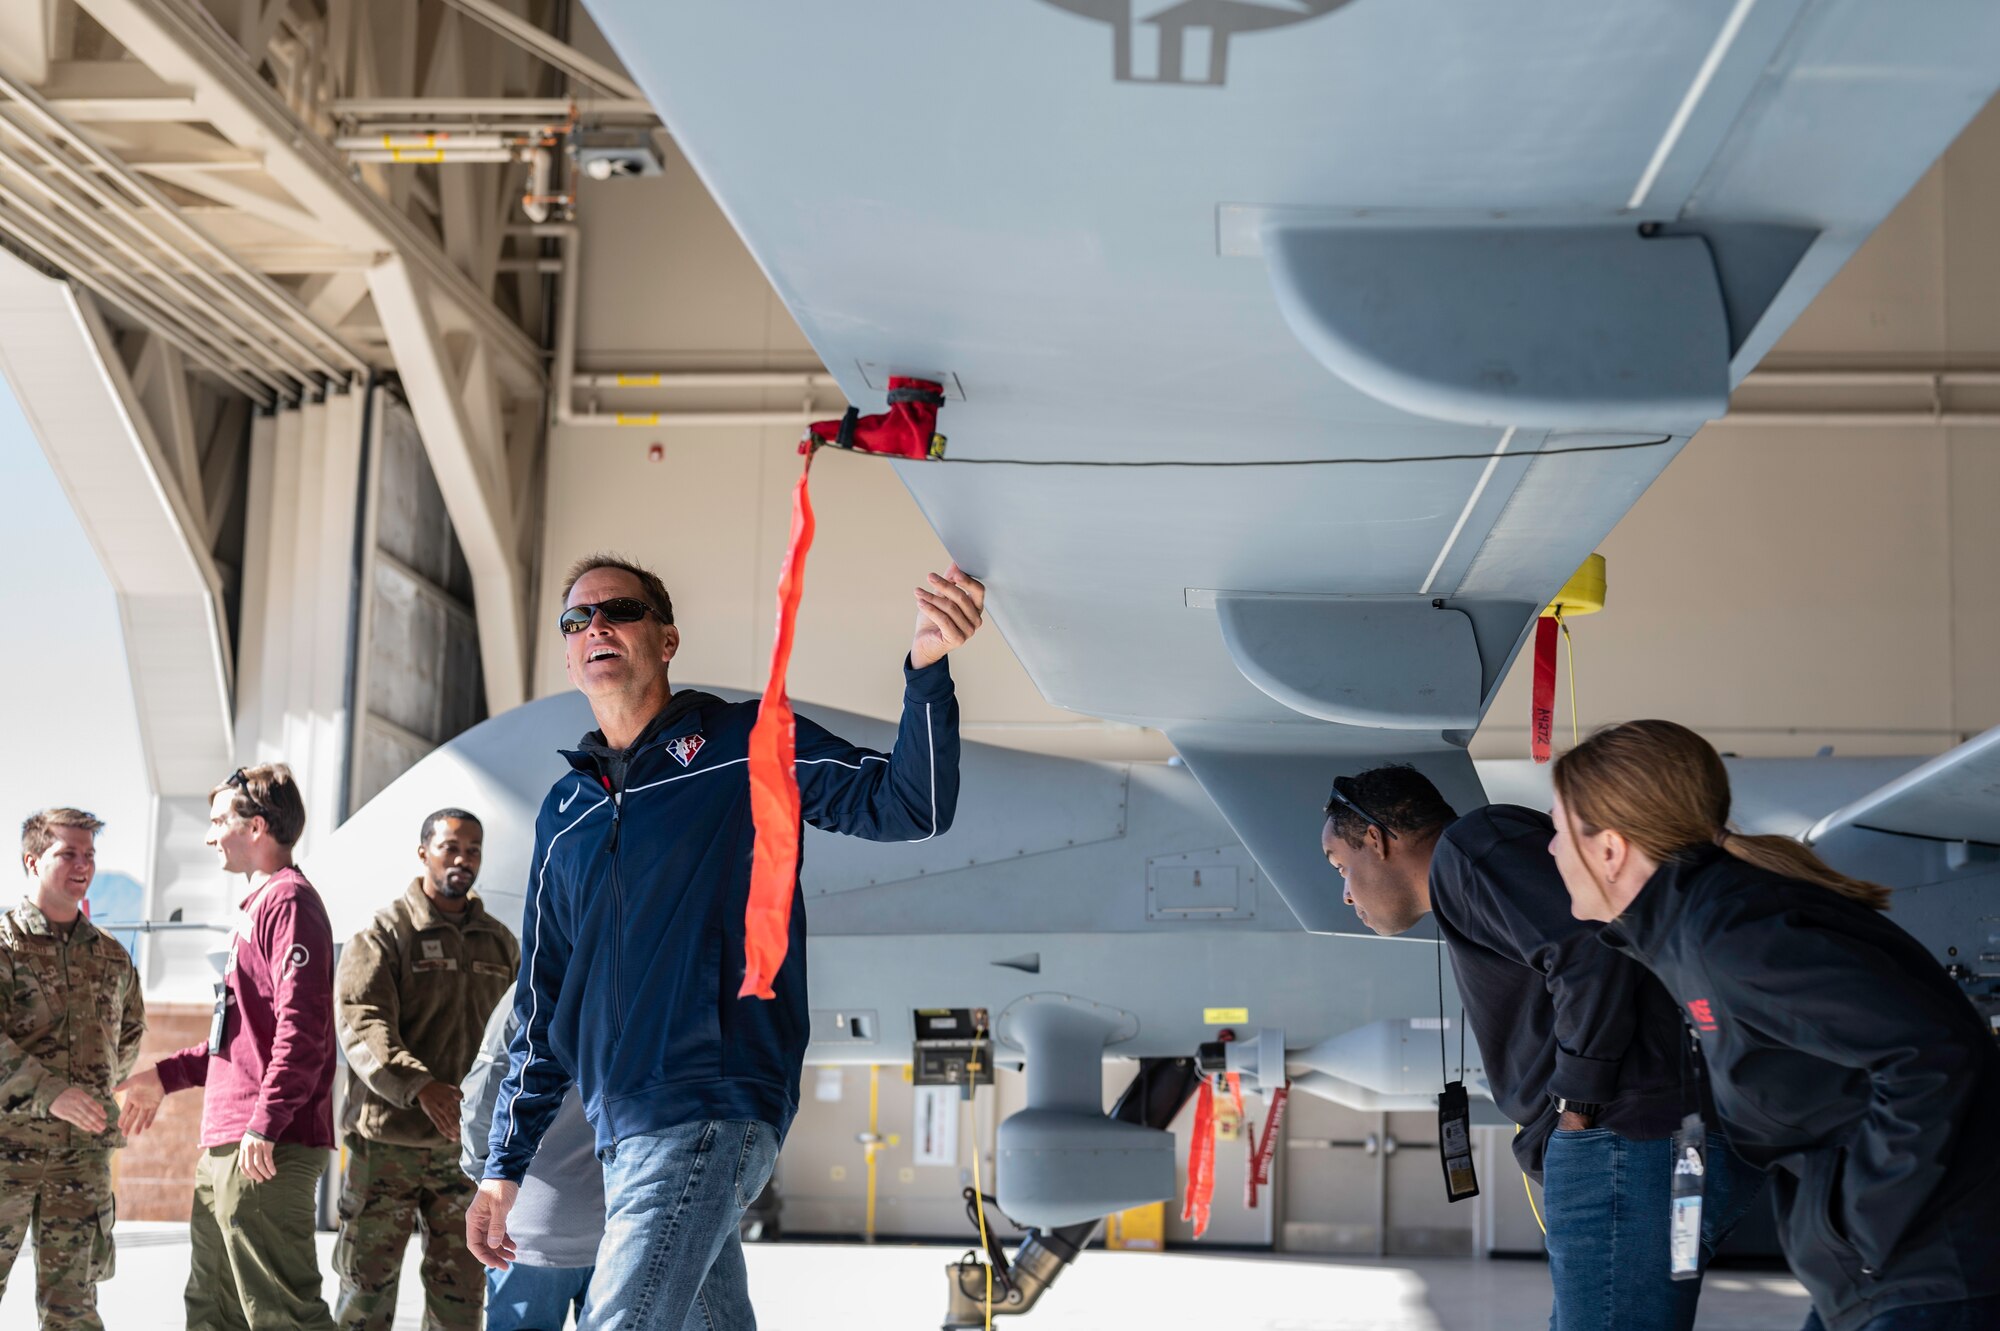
[334,879,520,1331]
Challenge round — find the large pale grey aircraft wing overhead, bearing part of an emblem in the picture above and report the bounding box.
[590,0,2000,929]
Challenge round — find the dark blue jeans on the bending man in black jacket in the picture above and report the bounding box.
[1542,1127,1764,1331]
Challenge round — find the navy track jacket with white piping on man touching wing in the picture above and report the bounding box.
[486,662,958,1181]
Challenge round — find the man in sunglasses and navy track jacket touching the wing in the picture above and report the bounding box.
[466,556,986,1331]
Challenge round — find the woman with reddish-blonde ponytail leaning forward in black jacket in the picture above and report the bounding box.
[1550,721,2000,1331]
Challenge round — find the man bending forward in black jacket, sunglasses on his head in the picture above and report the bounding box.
[1320,765,1758,1331]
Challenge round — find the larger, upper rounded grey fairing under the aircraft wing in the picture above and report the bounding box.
[1264,220,1730,434]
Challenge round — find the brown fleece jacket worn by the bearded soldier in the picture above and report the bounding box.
[334,879,520,1151]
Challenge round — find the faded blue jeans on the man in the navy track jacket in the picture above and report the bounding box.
[580,1119,778,1331]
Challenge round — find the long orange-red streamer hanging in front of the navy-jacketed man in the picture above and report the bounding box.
[736,450,812,999]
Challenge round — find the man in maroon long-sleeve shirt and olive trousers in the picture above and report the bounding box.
[118,763,334,1331]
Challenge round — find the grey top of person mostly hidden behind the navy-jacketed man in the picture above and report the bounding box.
[458,989,604,1267]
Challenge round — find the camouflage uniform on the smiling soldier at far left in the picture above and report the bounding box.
[0,901,146,1331]
